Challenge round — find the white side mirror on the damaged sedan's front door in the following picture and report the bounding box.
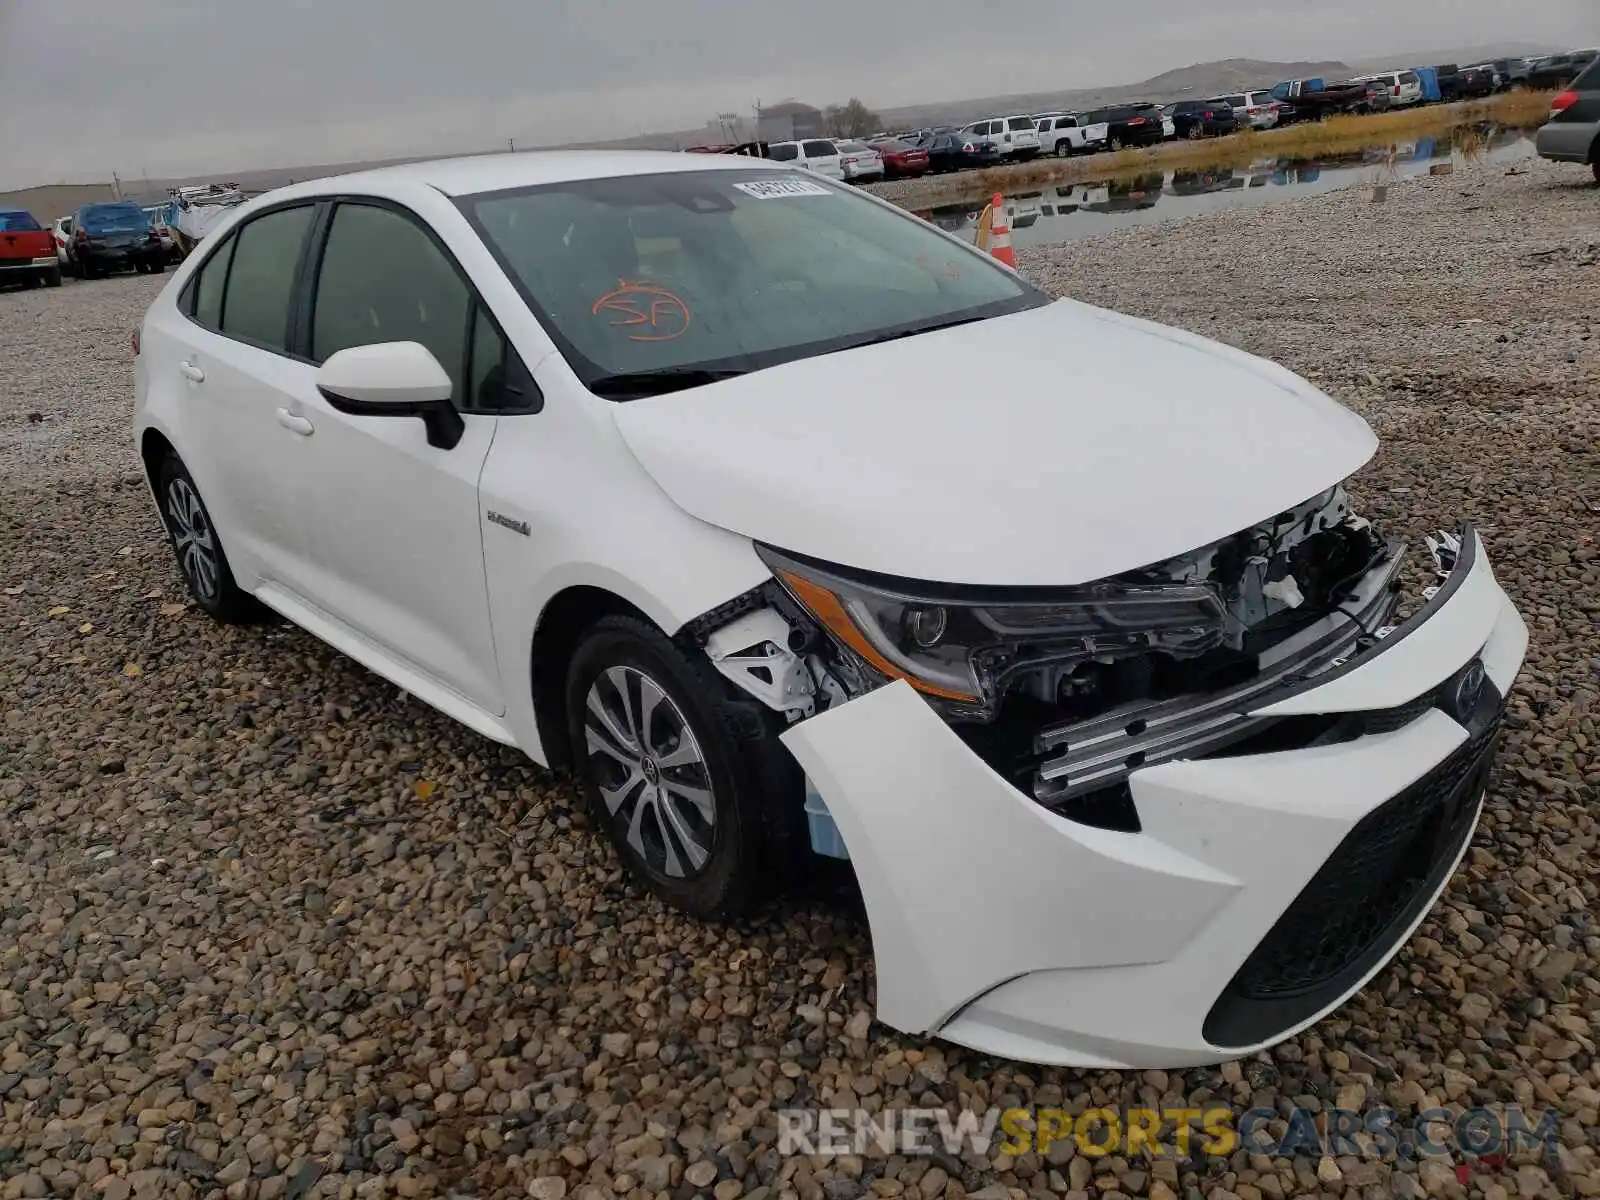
[317,342,467,450]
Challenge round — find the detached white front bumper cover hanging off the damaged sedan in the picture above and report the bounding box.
[784,533,1528,1067]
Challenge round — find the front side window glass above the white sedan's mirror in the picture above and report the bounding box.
[307,203,472,403]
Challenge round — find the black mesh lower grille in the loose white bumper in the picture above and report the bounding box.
[1205,700,1501,1046]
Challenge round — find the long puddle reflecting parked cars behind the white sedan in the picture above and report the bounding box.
[917,130,1534,248]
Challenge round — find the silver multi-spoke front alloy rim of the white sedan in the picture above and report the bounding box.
[584,666,717,878]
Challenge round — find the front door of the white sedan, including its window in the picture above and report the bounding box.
[288,198,506,715]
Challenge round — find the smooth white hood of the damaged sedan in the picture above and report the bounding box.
[614,301,1378,586]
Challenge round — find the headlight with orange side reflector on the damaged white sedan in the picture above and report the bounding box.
[758,546,1227,715]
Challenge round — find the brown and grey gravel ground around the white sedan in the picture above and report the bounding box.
[0,165,1600,1200]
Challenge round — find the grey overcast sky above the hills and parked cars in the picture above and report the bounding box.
[0,0,1600,187]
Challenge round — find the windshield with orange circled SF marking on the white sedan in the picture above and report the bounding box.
[458,170,1050,398]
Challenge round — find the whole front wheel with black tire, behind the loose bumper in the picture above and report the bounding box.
[566,616,803,920]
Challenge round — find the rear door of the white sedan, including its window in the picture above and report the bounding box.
[162,203,317,601]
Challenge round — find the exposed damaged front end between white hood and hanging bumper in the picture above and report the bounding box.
[698,486,1433,830]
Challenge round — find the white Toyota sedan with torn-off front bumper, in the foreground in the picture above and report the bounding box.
[136,152,1526,1067]
